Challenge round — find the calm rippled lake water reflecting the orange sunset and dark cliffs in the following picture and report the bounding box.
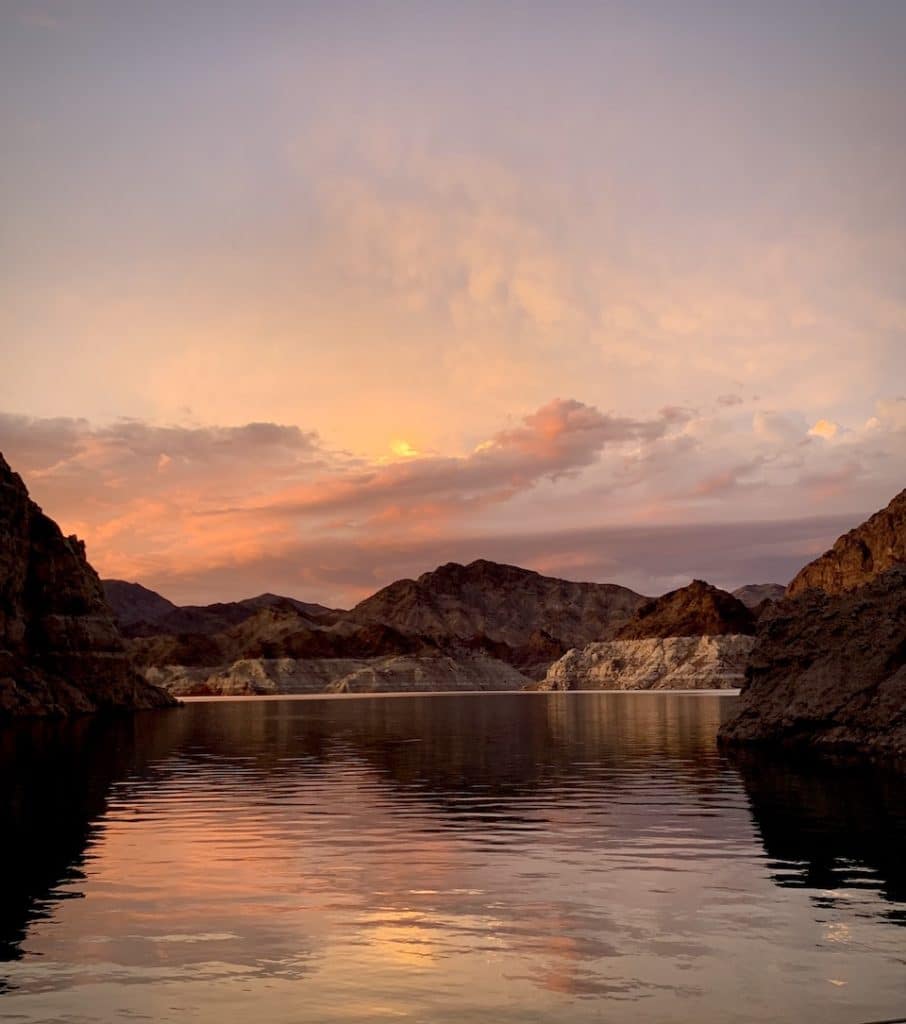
[0,693,906,1024]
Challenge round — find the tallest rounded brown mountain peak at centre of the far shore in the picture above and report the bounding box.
[349,560,645,647]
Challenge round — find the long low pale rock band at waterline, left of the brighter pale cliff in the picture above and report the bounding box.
[145,654,528,696]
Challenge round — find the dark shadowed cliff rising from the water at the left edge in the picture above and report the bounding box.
[0,456,172,715]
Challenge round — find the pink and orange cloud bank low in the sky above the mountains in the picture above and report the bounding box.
[0,395,906,605]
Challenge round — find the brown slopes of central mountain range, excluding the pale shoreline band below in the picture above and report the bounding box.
[113,561,645,684]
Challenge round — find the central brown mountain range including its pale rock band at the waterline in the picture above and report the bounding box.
[125,561,645,693]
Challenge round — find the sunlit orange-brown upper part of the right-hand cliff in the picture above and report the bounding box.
[786,490,906,597]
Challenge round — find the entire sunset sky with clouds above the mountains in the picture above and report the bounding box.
[0,0,906,606]
